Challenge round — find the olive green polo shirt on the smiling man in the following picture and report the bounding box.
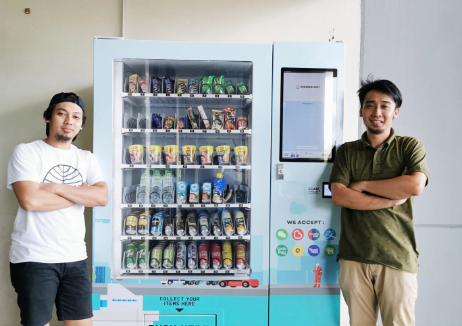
[329,129,430,273]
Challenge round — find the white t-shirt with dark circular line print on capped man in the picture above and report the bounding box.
[7,140,104,263]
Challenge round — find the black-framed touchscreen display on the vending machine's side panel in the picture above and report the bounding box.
[279,68,337,162]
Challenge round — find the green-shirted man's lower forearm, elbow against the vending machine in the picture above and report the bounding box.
[331,182,407,211]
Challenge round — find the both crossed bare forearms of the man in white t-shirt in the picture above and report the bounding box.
[12,181,108,212]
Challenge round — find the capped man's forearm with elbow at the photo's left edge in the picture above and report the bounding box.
[12,181,75,212]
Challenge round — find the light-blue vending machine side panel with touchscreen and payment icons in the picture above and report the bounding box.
[269,42,345,326]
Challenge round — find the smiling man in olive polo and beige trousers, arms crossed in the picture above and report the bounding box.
[330,80,430,326]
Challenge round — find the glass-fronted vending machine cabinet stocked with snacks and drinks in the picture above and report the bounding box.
[92,39,272,326]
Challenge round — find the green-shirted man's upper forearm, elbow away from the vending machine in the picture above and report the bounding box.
[348,172,427,200]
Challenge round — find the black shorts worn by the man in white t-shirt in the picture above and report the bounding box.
[10,259,93,326]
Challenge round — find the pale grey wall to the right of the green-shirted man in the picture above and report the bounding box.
[361,0,462,326]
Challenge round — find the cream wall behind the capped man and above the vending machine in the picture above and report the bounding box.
[0,0,361,326]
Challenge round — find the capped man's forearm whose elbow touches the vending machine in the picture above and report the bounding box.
[40,181,108,207]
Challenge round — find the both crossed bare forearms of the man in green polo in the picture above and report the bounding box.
[331,170,427,210]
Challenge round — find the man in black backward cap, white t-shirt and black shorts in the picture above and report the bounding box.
[7,93,108,326]
